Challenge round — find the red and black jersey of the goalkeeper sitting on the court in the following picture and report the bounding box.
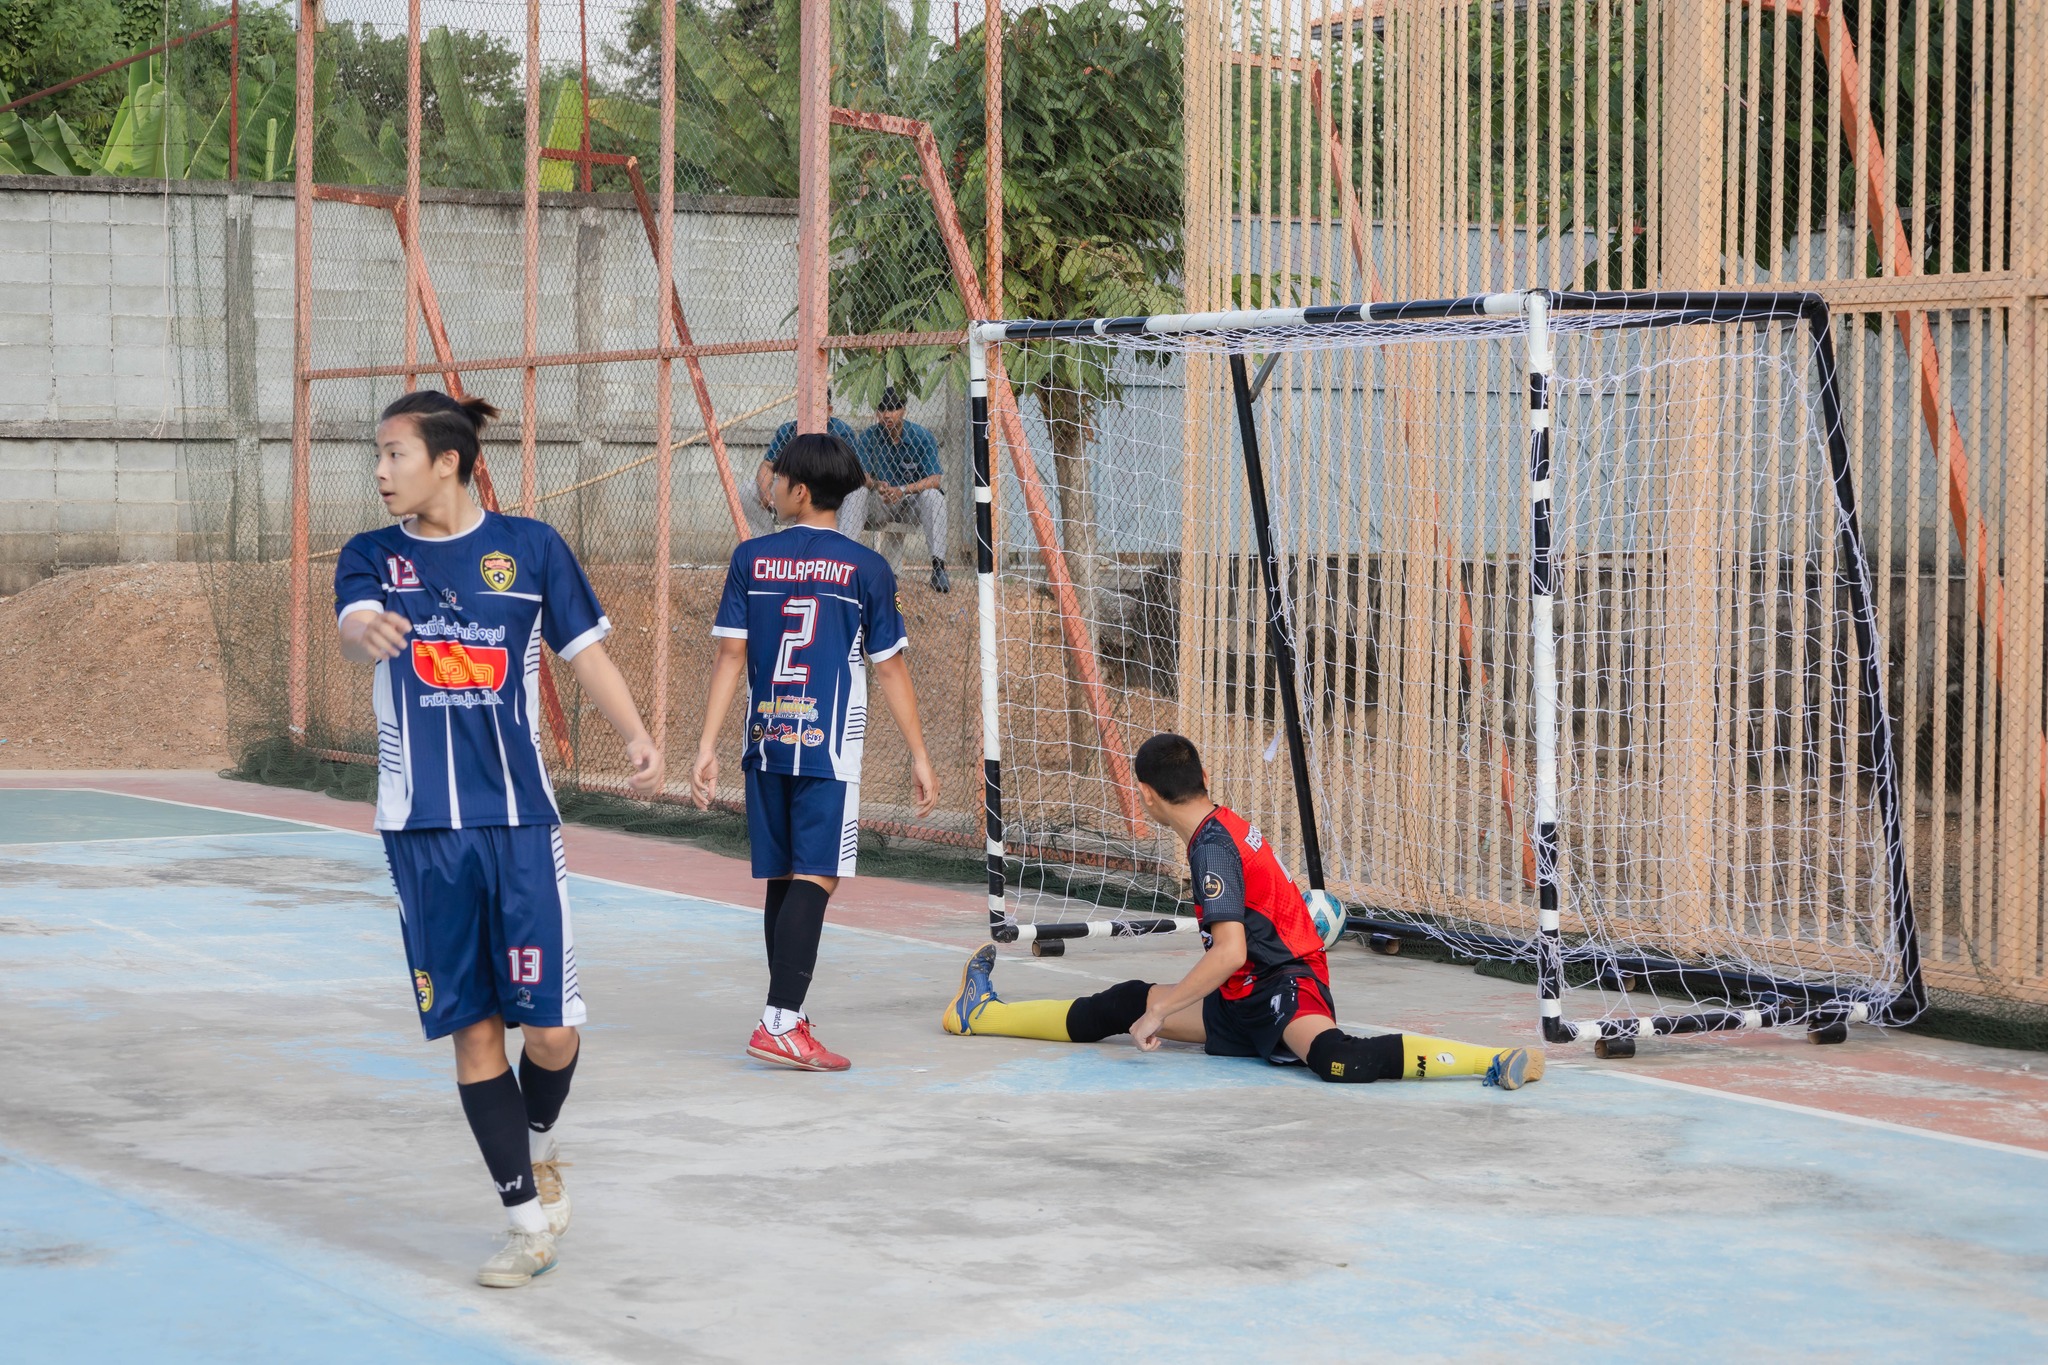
[1188,806,1329,1001]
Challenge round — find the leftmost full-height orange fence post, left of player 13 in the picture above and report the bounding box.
[285,0,319,743]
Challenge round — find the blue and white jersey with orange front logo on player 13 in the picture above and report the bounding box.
[334,512,612,829]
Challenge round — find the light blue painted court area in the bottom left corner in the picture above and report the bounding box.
[0,1150,535,1365]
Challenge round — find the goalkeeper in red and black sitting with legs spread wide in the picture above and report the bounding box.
[942,735,1542,1091]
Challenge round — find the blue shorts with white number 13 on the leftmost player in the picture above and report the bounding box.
[385,825,586,1040]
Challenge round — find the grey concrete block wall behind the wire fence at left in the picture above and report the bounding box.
[0,176,973,593]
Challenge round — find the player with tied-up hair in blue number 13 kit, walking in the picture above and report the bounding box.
[334,391,662,1289]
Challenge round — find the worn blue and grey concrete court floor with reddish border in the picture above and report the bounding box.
[0,774,2048,1363]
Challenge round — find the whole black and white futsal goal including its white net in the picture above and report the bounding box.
[967,291,1925,1054]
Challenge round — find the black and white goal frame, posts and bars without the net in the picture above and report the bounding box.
[967,291,1925,1044]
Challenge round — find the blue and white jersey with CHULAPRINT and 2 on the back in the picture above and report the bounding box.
[711,526,909,782]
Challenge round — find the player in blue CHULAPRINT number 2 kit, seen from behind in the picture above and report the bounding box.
[690,432,938,1070]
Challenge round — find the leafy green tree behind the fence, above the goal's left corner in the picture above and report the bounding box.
[834,0,1182,417]
